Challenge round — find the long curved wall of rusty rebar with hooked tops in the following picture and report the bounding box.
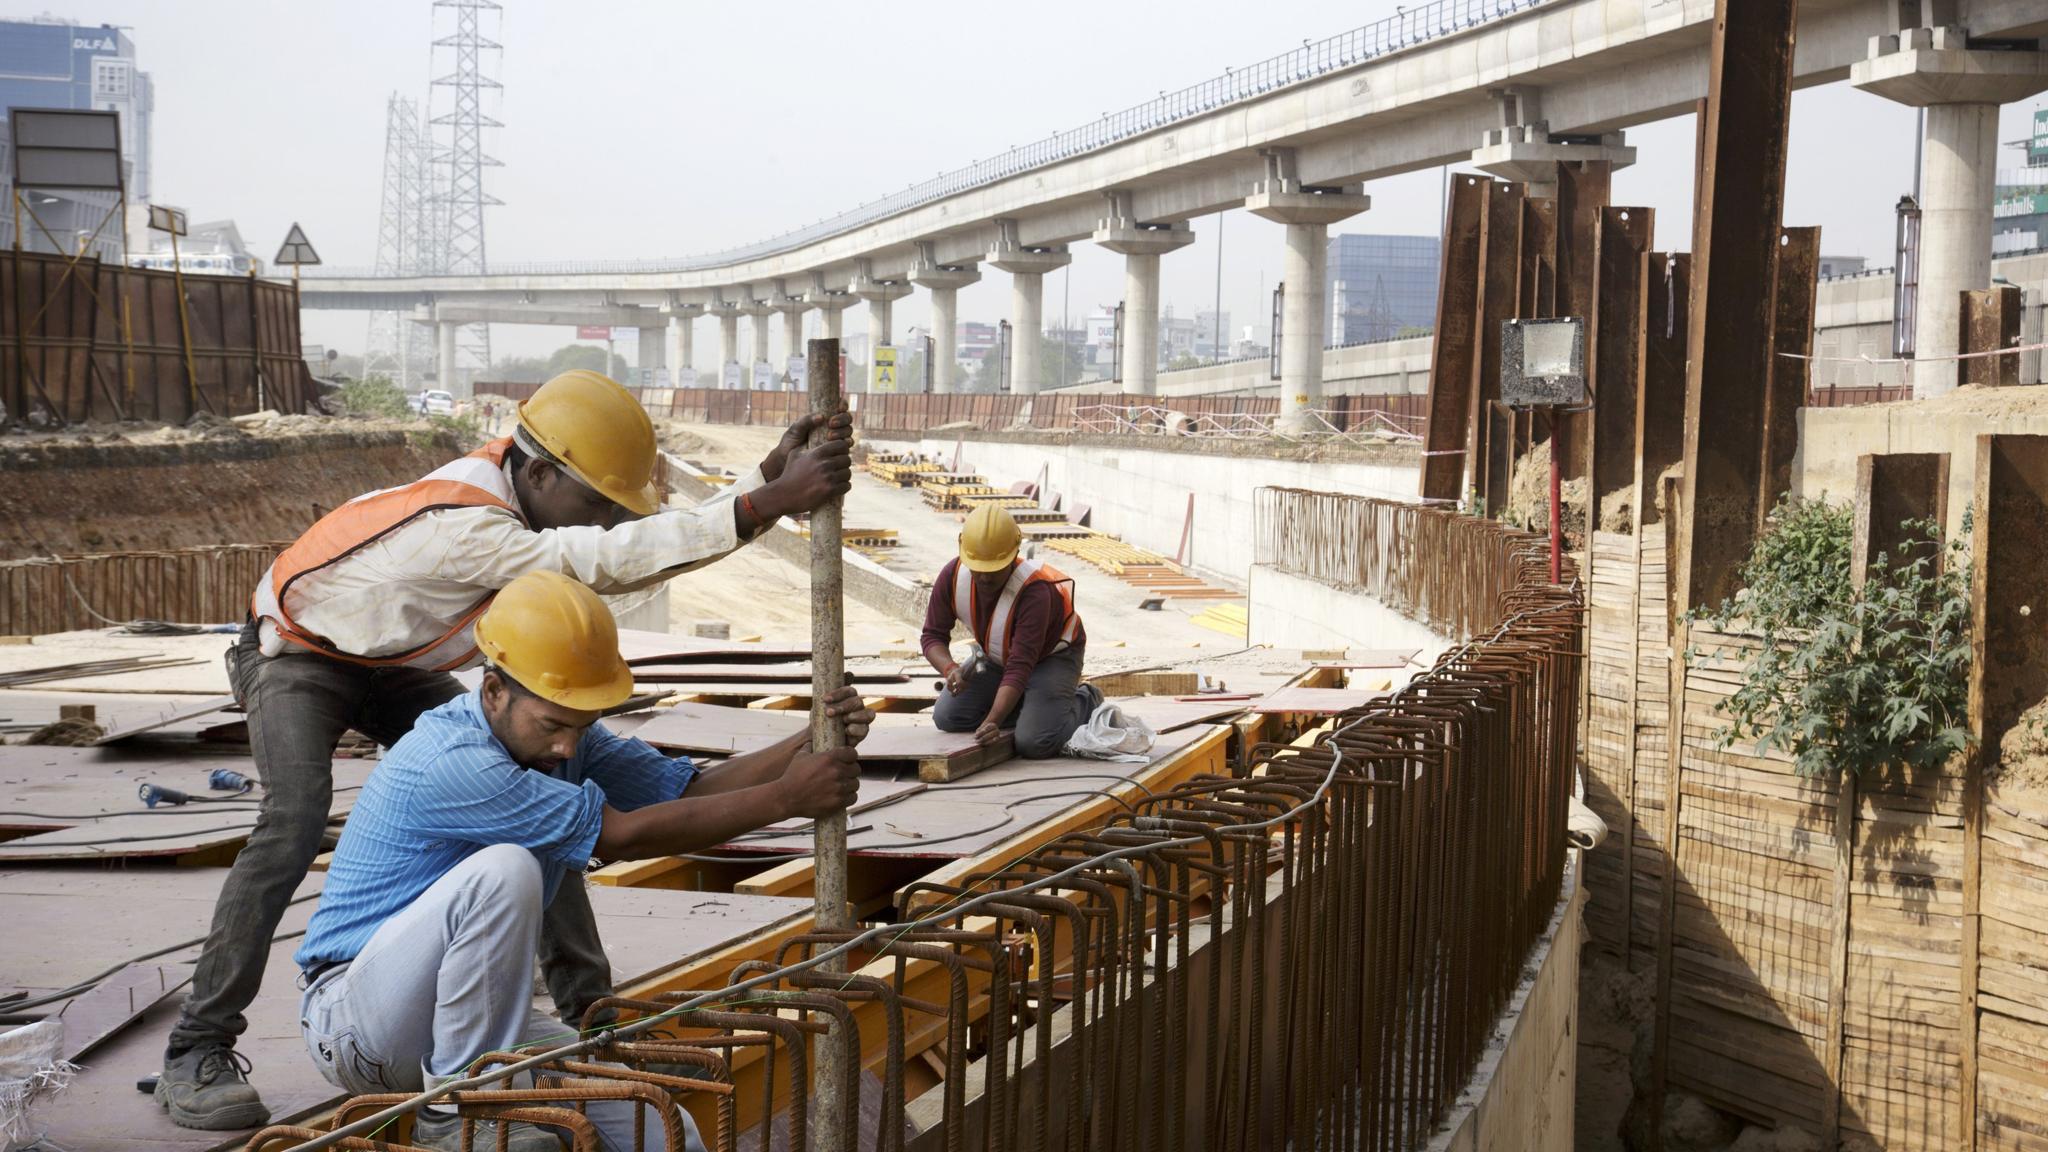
[276,492,1583,1152]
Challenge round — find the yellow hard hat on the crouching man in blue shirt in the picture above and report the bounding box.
[477,572,633,711]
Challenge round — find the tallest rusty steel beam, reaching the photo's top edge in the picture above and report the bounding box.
[1671,0,1796,614]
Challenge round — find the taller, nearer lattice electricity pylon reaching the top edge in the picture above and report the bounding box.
[428,0,504,387]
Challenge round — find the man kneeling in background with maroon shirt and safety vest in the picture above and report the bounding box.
[920,504,1102,760]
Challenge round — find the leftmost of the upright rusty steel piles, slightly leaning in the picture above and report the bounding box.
[1421,174,1493,500]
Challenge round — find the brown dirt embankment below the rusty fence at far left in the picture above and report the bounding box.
[0,414,467,560]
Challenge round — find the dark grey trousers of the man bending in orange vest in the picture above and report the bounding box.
[170,625,612,1050]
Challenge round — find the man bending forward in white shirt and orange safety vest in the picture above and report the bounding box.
[156,371,852,1129]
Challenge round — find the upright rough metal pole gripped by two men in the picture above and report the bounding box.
[791,338,860,1148]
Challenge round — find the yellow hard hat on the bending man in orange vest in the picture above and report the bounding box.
[518,369,657,517]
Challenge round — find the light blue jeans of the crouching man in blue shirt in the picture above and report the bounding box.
[299,845,705,1152]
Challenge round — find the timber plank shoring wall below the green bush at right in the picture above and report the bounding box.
[1585,525,2015,1150]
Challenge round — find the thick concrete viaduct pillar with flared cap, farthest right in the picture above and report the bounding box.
[1849,21,2048,398]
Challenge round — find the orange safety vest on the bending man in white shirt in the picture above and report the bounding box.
[250,437,518,672]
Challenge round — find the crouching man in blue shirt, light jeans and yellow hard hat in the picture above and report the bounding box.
[295,572,874,1152]
